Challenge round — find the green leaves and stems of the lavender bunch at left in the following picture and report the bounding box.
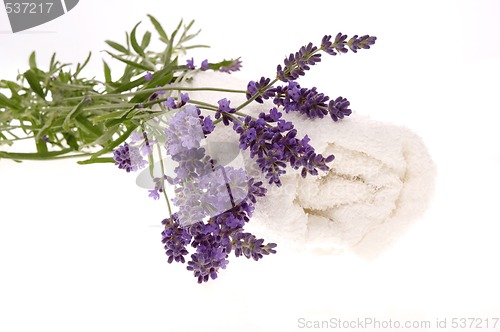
[0,15,238,164]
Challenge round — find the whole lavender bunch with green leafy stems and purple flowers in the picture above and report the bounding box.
[0,16,376,283]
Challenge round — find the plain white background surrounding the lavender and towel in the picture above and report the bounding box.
[0,0,500,332]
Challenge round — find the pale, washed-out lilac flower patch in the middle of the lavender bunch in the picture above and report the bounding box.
[165,105,256,226]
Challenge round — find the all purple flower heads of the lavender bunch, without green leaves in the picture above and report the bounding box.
[114,33,376,283]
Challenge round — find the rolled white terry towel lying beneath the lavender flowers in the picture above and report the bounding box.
[179,73,435,257]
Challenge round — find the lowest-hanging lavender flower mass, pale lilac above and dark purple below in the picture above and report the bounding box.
[162,105,276,283]
